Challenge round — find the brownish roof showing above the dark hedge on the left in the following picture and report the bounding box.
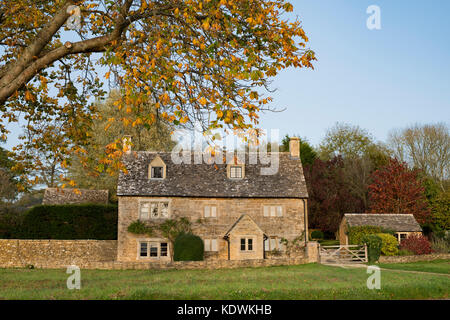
[42,188,108,205]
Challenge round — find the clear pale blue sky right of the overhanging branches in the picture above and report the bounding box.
[6,0,450,148]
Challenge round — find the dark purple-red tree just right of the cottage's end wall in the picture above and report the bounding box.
[304,157,365,232]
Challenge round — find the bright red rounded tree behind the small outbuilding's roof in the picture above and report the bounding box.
[369,159,430,224]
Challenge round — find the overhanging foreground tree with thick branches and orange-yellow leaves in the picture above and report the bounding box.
[0,0,315,186]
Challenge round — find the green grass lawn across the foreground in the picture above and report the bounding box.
[0,260,450,299]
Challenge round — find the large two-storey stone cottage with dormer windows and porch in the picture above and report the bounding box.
[117,138,308,262]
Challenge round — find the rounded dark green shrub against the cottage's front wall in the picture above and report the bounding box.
[173,233,204,261]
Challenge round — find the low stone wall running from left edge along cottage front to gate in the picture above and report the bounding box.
[0,239,318,269]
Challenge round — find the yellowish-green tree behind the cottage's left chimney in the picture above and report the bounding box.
[67,90,175,201]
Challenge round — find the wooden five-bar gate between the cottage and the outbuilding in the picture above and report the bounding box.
[319,245,367,264]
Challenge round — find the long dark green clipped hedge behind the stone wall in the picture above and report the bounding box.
[11,204,118,240]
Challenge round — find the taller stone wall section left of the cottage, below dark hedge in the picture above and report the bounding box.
[0,239,117,268]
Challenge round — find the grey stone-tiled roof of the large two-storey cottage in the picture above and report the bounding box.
[117,151,308,198]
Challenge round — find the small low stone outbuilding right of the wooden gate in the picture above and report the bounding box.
[338,213,422,245]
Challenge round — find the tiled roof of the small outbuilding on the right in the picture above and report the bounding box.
[344,213,422,232]
